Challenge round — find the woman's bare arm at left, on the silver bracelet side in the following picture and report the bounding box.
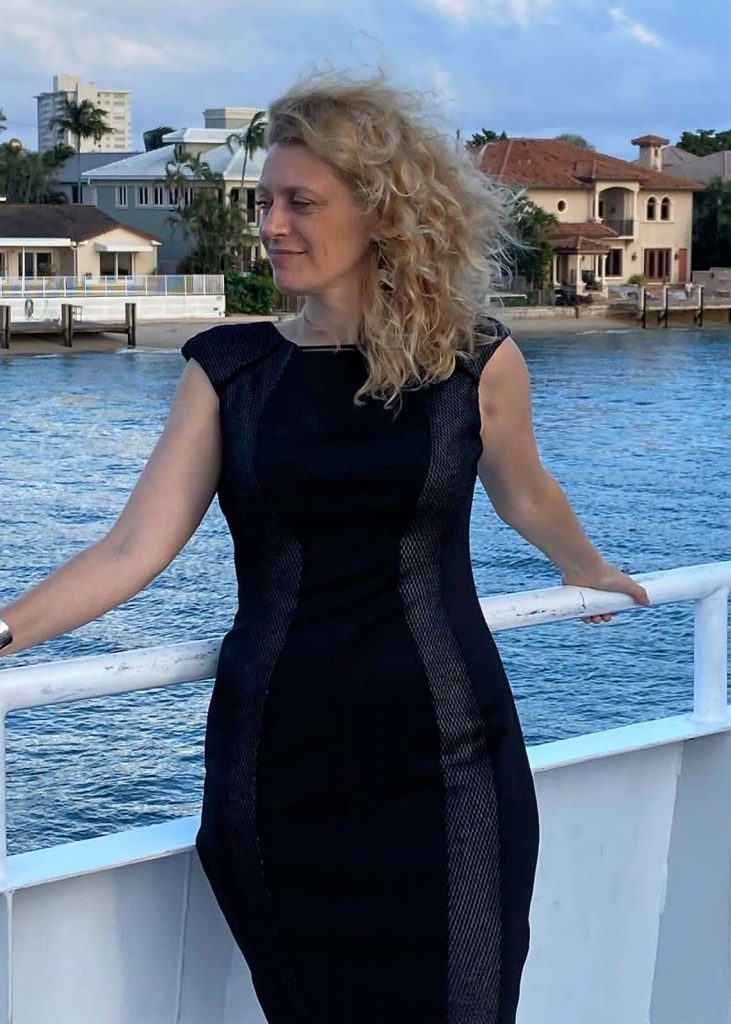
[0,359,221,657]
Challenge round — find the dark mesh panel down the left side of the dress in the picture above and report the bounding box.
[196,352,312,1024]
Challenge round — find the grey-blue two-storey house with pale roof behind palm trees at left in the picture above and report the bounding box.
[83,108,264,273]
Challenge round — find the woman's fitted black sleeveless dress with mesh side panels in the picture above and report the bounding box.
[181,319,539,1024]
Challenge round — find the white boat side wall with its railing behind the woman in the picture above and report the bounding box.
[0,562,731,1024]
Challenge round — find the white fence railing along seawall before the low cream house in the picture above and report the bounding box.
[0,273,224,299]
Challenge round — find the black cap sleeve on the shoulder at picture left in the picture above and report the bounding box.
[180,321,276,396]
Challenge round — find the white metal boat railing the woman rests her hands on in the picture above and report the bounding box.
[0,561,731,877]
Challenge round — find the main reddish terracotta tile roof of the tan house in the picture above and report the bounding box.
[479,138,705,191]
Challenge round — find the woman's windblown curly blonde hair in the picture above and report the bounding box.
[265,65,517,407]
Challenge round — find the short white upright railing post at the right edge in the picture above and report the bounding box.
[693,587,729,722]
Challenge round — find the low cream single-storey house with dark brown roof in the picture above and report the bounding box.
[0,203,161,282]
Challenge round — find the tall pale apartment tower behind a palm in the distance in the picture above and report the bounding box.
[36,75,132,153]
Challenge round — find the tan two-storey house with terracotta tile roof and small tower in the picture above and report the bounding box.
[478,135,704,294]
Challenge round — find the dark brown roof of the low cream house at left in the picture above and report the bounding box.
[0,203,160,243]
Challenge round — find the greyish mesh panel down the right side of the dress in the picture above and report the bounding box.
[399,368,502,1024]
